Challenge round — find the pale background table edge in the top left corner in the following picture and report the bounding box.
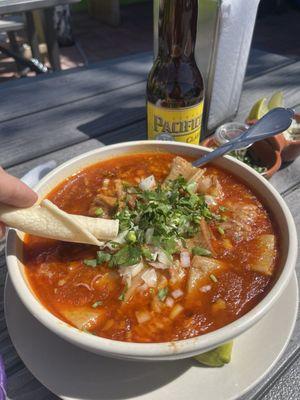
[0,0,80,14]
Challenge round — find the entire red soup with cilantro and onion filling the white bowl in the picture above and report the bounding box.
[24,153,278,342]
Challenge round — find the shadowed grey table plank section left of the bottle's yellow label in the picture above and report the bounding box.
[0,82,145,167]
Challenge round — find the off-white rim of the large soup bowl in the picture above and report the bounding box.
[6,140,298,360]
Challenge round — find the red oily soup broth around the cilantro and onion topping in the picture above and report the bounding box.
[23,153,278,342]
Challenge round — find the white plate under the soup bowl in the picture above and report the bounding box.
[5,274,298,400]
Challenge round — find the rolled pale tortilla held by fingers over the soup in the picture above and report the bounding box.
[0,200,119,246]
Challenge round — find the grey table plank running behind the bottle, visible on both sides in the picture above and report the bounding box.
[0,62,300,167]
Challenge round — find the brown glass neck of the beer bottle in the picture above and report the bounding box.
[158,0,198,60]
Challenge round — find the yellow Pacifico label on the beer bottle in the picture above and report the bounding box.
[147,101,203,144]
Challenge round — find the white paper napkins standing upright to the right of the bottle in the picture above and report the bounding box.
[208,0,259,129]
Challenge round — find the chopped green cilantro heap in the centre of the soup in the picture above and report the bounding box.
[115,177,213,254]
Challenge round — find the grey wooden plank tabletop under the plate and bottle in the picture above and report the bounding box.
[0,48,300,400]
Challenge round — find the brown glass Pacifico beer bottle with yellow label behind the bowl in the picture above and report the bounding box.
[147,0,204,144]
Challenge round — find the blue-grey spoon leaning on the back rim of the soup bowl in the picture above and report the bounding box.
[193,107,294,167]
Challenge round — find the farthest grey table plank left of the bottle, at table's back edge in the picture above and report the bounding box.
[0,53,152,122]
